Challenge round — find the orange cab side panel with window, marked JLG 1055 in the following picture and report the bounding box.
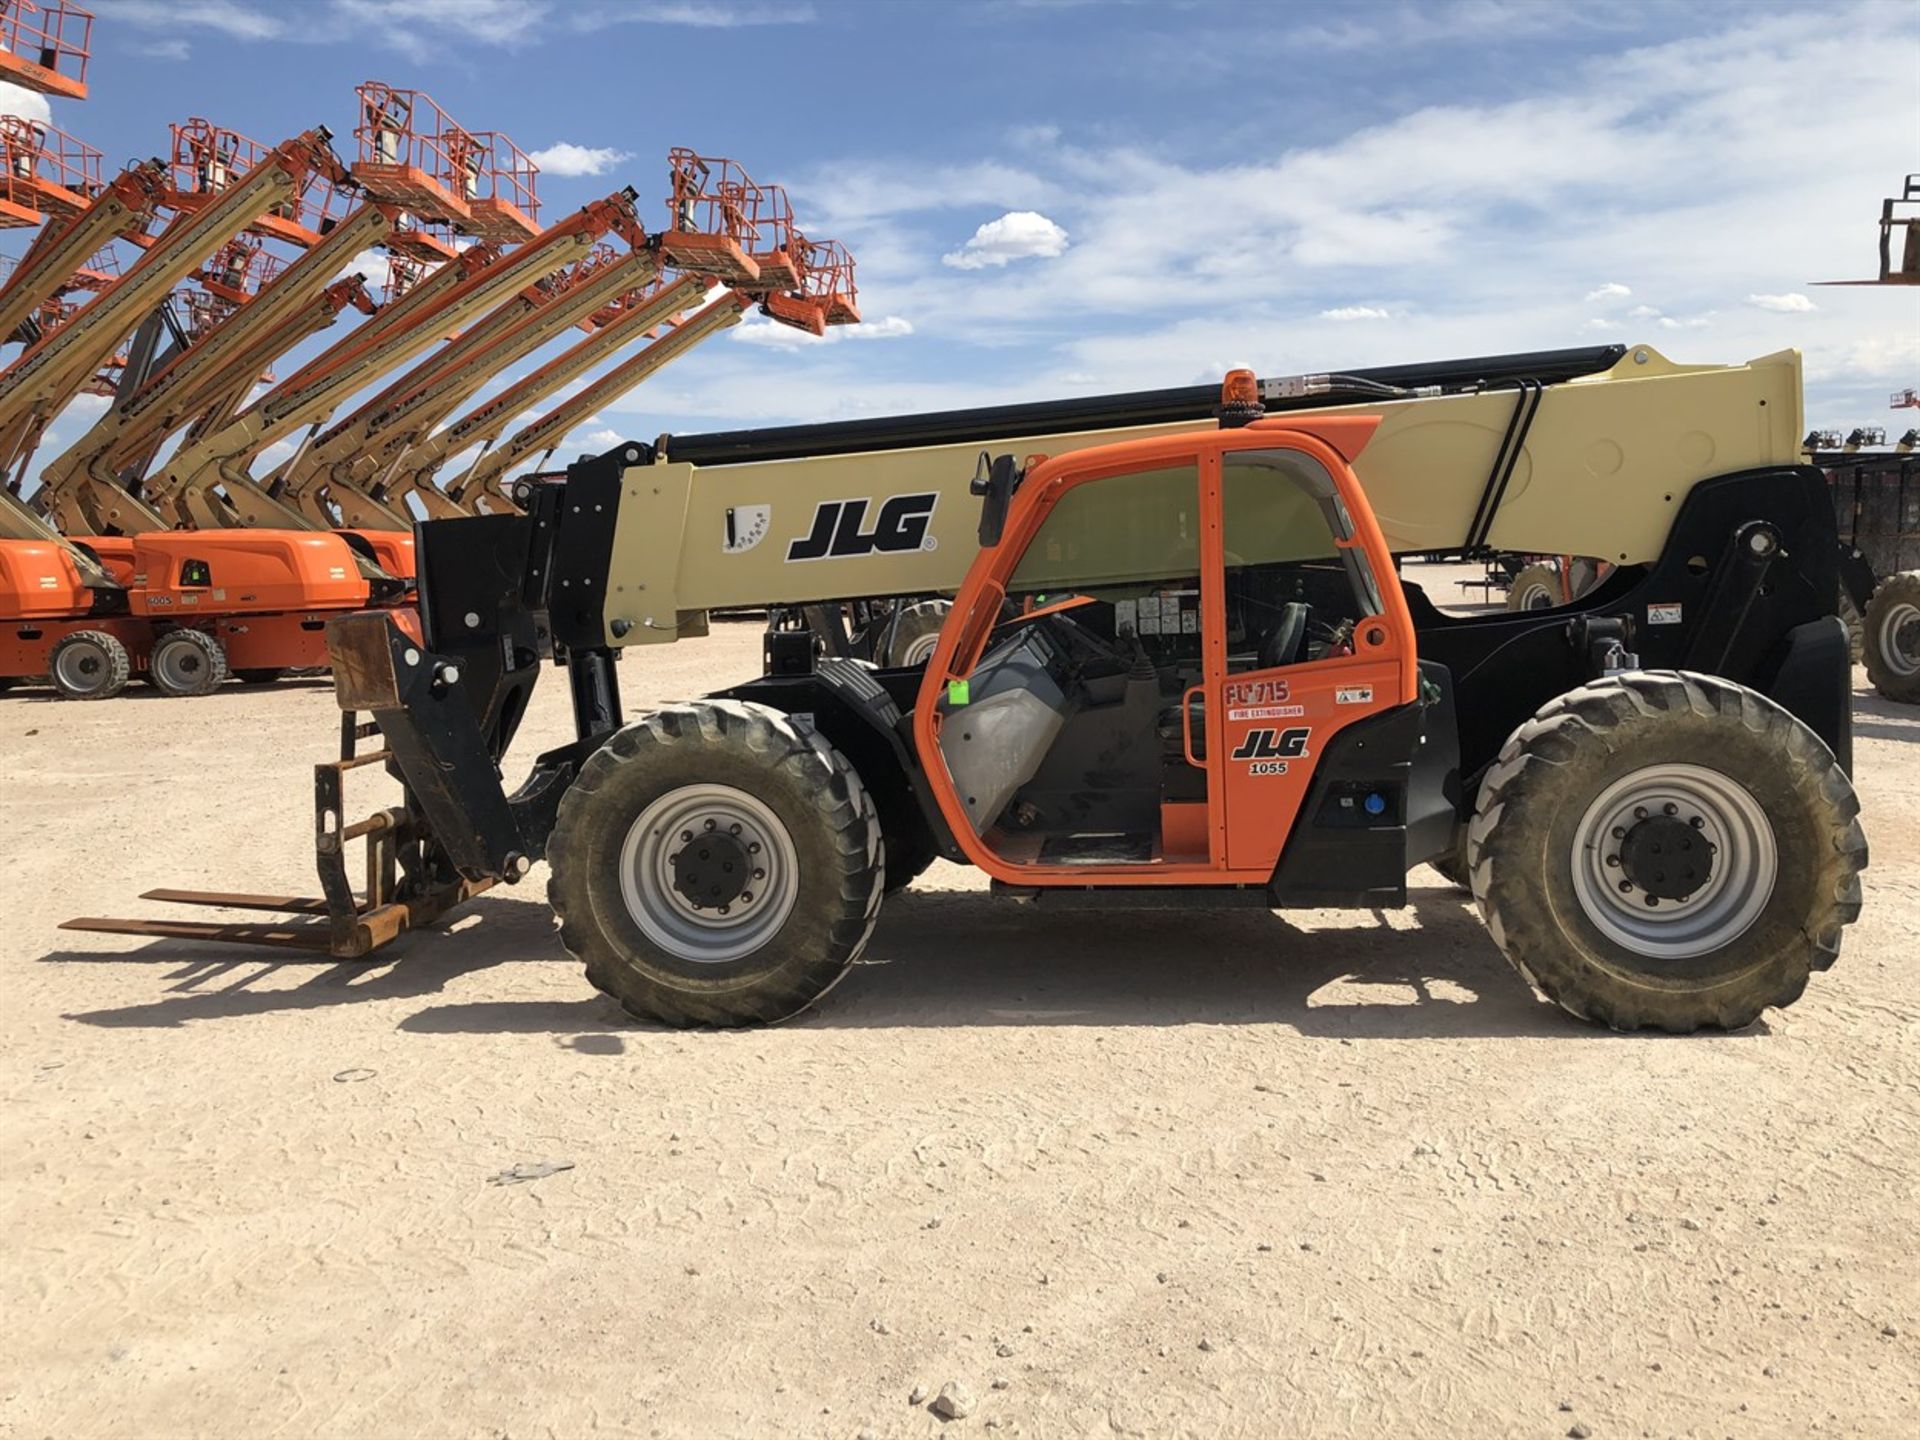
[1204,443,1413,872]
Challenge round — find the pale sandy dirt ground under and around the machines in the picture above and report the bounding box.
[0,626,1920,1440]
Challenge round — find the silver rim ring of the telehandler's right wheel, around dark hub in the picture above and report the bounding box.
[1572,764,1780,960]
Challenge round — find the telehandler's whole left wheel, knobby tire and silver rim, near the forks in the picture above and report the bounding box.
[547,701,887,1025]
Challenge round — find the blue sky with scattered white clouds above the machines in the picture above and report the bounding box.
[0,0,1920,491]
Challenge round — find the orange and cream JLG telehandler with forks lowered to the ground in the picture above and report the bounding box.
[69,348,1866,1031]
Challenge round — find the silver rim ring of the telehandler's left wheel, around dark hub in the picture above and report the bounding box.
[620,785,801,964]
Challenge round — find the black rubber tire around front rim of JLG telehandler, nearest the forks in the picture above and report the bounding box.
[547,701,887,1027]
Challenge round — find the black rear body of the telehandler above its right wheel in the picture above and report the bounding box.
[1407,467,1853,776]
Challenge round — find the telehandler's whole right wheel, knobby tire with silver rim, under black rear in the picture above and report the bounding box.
[1467,670,1866,1033]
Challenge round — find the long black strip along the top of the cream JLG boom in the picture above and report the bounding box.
[660,346,1626,465]
